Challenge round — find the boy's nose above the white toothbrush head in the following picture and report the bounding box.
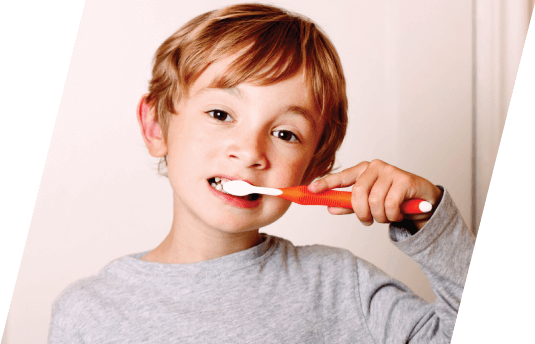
[226,133,269,170]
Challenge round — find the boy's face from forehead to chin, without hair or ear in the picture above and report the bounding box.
[162,59,323,233]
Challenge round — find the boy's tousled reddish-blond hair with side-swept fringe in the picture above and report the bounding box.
[146,4,347,181]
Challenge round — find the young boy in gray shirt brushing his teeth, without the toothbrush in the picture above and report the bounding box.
[49,5,474,343]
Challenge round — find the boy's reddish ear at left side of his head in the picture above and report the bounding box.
[136,94,167,157]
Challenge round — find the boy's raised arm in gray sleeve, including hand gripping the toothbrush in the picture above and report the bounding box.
[311,162,475,343]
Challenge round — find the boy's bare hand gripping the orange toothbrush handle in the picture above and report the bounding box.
[308,160,442,229]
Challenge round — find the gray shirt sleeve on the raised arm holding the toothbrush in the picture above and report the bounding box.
[357,187,475,343]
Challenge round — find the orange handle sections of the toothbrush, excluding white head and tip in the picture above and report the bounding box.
[278,185,430,215]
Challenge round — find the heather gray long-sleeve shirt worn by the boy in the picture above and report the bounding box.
[49,190,475,344]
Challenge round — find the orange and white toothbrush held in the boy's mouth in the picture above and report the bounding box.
[223,180,433,215]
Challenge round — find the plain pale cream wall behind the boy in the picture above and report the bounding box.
[2,0,532,344]
